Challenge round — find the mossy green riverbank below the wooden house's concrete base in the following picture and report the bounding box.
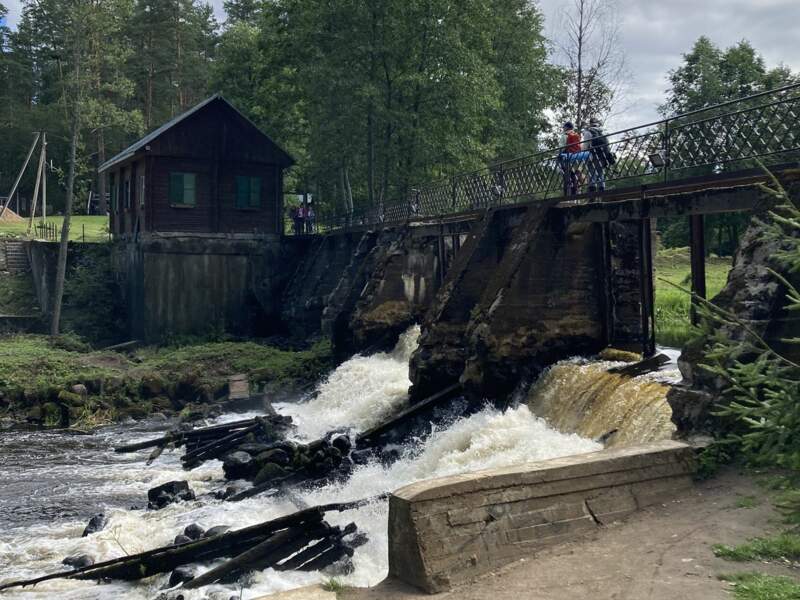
[0,335,332,426]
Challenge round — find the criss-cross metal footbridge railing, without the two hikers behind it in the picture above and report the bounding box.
[300,82,800,233]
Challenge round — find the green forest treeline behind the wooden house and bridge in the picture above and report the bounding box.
[0,0,792,248]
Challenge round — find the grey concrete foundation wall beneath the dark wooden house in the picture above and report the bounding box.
[115,234,310,340]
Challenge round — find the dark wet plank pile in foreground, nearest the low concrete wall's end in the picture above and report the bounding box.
[0,497,379,590]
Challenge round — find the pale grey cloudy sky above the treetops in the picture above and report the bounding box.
[2,0,800,130]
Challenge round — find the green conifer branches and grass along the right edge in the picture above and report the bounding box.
[693,171,800,600]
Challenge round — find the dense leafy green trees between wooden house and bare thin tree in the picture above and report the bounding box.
[214,0,559,213]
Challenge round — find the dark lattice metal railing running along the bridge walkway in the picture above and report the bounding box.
[310,83,800,231]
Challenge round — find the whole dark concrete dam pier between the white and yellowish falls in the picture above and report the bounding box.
[411,203,608,401]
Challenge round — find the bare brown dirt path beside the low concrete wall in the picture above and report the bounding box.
[339,471,800,600]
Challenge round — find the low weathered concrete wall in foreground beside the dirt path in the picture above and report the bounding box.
[389,441,694,593]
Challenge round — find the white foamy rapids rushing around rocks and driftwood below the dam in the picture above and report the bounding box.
[0,328,600,600]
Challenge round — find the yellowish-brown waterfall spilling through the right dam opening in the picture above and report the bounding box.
[528,359,680,446]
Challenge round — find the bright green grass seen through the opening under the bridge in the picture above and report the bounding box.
[655,248,731,348]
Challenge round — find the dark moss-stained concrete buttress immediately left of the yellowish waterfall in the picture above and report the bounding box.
[462,206,608,399]
